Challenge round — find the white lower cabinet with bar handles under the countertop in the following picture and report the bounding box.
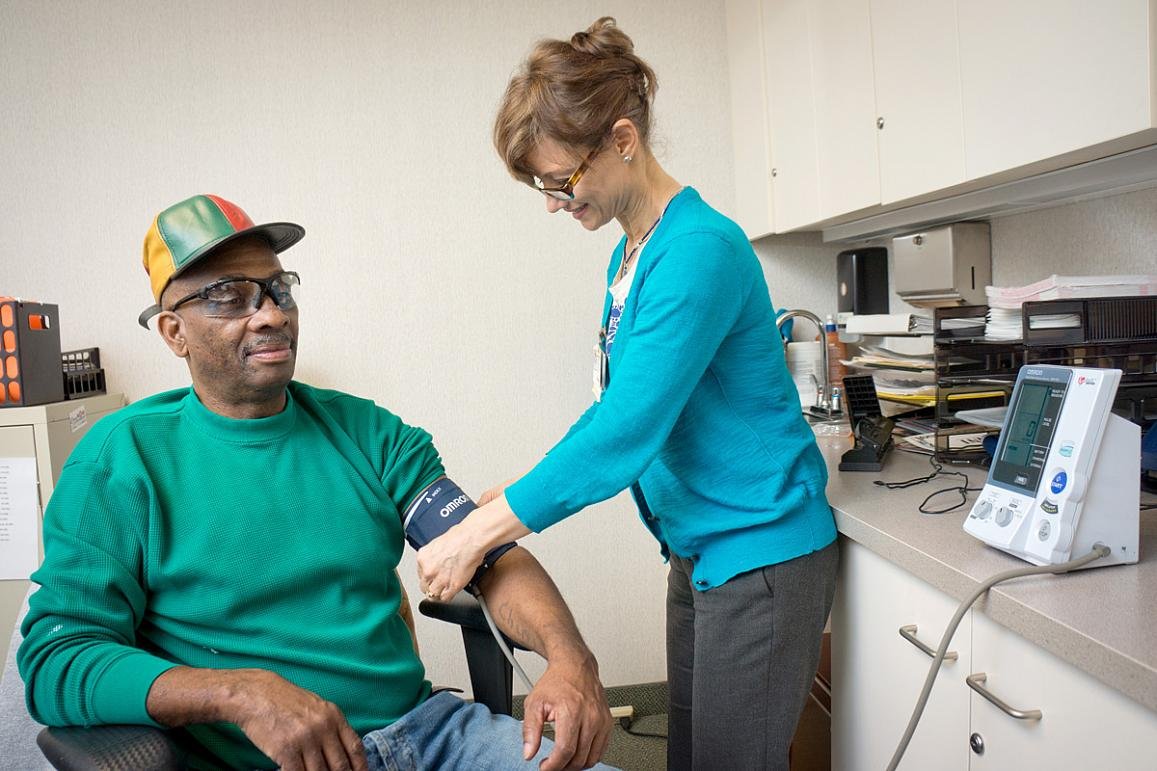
[832,538,1157,771]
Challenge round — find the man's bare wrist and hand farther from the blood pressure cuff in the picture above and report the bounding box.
[147,667,367,771]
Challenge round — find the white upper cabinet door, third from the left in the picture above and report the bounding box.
[811,0,879,219]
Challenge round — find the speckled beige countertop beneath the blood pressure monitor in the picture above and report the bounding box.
[818,436,1157,712]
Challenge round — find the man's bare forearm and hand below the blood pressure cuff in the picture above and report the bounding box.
[479,546,611,771]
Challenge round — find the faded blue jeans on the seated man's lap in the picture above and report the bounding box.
[362,692,611,771]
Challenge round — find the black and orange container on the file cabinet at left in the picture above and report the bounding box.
[0,298,65,407]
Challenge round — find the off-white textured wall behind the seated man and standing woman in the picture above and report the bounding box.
[0,0,734,685]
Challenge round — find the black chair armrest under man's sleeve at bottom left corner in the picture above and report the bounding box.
[36,726,185,771]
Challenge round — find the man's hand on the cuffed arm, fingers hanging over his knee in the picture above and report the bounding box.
[522,653,611,771]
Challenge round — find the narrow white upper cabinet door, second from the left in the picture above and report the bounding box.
[762,0,820,233]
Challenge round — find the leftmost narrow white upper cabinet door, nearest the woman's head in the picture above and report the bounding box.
[727,0,774,238]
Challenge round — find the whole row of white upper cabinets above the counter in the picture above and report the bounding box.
[727,0,1157,232]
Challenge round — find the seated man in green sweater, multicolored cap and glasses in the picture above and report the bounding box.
[19,196,611,769]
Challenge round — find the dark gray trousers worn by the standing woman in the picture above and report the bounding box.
[666,542,839,771]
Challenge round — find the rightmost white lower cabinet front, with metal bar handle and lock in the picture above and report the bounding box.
[970,611,1157,771]
